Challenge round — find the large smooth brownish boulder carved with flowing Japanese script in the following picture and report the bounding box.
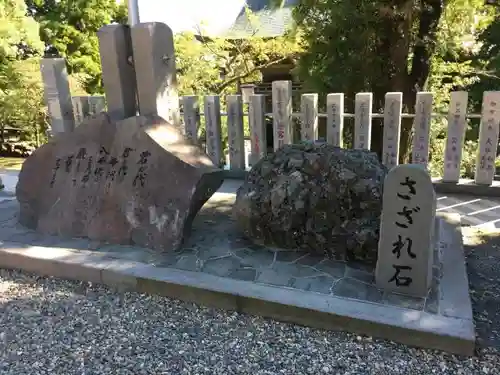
[16,113,223,251]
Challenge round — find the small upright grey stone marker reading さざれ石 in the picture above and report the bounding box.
[375,164,436,297]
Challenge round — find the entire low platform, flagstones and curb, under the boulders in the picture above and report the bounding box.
[0,193,475,355]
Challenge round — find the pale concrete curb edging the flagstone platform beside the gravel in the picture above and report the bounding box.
[0,218,475,355]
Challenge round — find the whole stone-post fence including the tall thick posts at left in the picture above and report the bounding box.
[40,22,500,196]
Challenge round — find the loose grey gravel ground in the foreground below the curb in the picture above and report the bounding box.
[0,270,500,375]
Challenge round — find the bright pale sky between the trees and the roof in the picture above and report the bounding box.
[138,0,245,35]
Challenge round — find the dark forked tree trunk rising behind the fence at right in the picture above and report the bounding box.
[372,0,444,163]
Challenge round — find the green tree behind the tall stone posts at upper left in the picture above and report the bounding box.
[26,0,127,94]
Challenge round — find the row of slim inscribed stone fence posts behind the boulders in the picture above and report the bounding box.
[72,81,500,185]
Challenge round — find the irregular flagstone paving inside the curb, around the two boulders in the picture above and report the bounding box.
[0,183,440,314]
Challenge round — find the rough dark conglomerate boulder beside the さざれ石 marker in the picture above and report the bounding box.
[233,143,387,264]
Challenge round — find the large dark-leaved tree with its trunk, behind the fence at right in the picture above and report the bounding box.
[294,0,492,167]
